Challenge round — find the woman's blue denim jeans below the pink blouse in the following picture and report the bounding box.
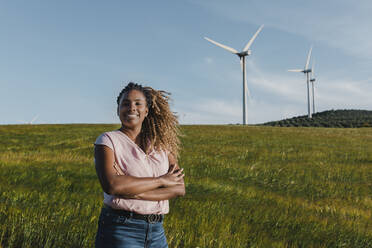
[95,207,168,248]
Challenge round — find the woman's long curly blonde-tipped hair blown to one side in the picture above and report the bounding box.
[117,82,181,158]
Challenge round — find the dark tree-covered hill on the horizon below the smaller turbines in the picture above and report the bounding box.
[262,109,372,128]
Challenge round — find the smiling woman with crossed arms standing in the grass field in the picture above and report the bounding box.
[94,83,185,248]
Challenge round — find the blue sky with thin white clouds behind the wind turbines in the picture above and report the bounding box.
[0,0,372,124]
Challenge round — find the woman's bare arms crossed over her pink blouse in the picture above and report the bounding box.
[94,145,185,201]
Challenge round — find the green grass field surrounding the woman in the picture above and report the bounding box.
[0,125,372,248]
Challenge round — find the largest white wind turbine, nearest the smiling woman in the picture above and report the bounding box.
[204,25,264,125]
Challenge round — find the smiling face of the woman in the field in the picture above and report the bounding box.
[118,90,149,128]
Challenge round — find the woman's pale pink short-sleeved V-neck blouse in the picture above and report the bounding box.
[94,130,169,214]
